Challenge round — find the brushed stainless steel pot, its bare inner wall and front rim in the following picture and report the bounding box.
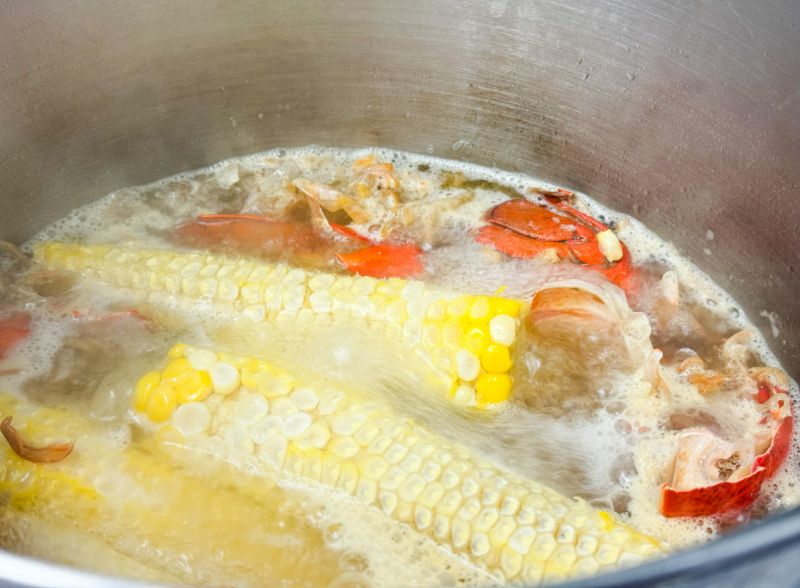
[0,0,800,586]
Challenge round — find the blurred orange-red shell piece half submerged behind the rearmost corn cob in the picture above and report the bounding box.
[175,214,324,255]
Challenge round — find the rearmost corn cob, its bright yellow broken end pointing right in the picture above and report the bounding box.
[35,243,524,406]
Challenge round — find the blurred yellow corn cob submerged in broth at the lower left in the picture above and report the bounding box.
[0,396,343,586]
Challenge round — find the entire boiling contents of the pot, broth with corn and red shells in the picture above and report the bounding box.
[0,147,800,586]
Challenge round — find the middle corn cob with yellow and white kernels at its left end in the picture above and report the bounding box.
[133,344,662,583]
